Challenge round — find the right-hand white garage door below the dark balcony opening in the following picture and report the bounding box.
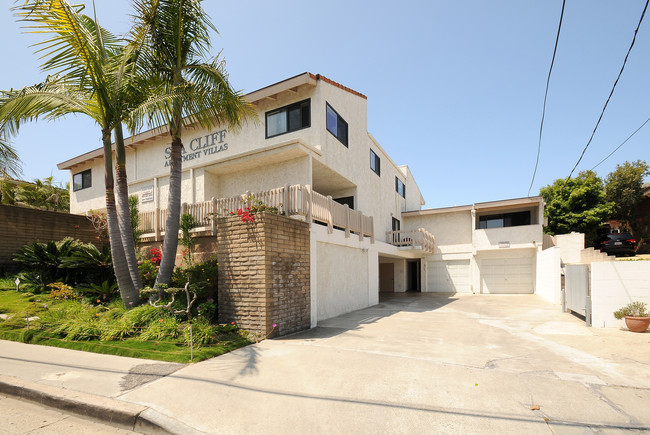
[479,256,535,293]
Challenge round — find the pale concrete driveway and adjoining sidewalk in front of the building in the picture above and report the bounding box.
[0,294,650,434]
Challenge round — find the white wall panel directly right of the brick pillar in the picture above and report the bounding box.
[310,224,381,328]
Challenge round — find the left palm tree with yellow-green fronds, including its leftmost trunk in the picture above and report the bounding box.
[0,0,139,308]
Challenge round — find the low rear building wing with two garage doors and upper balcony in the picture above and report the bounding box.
[402,197,544,293]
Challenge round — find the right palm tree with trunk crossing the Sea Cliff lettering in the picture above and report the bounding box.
[134,0,254,284]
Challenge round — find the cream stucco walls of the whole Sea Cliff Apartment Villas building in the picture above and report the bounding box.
[59,73,543,326]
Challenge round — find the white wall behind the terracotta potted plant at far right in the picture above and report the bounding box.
[591,261,650,328]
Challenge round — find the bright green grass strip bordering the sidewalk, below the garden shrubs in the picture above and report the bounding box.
[0,290,250,363]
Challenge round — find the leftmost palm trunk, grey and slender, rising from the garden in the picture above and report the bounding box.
[102,129,140,309]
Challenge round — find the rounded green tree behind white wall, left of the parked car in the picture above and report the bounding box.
[540,171,614,244]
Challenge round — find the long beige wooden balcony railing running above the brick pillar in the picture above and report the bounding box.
[139,184,375,243]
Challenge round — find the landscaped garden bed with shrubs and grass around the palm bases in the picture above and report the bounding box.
[0,239,251,363]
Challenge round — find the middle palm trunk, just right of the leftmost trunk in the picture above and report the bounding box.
[115,124,142,292]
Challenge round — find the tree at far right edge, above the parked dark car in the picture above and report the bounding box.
[605,160,650,239]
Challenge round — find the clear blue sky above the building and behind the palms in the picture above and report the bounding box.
[0,0,650,207]
